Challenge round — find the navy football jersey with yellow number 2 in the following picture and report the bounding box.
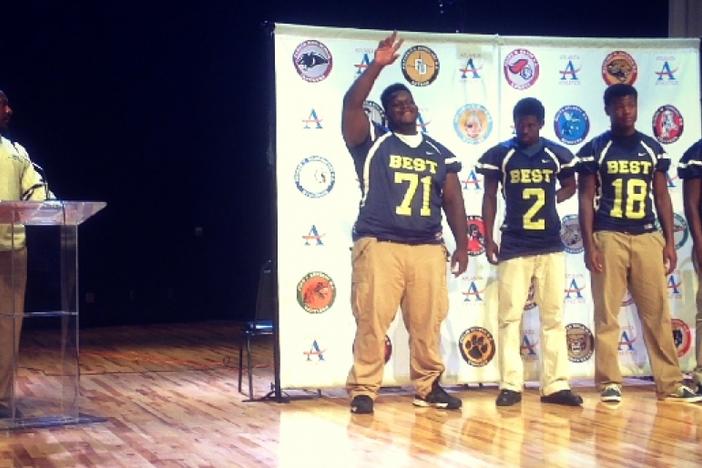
[476,138,576,260]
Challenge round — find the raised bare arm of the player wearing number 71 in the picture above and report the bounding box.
[341,31,403,147]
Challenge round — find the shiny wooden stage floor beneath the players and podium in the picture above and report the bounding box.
[0,322,702,467]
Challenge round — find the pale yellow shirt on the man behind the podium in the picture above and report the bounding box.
[0,136,47,251]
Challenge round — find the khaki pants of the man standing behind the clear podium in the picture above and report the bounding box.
[0,248,27,405]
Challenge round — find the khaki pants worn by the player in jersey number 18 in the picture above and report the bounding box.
[591,231,683,397]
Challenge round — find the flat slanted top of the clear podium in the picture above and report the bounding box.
[0,200,107,226]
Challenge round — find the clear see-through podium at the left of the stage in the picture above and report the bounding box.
[0,200,106,430]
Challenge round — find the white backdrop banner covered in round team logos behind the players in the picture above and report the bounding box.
[275,24,701,388]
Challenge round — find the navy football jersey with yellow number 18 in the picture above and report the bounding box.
[578,131,670,234]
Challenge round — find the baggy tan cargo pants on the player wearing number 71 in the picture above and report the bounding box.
[346,237,448,398]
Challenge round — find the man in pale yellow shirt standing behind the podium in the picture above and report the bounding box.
[0,90,49,418]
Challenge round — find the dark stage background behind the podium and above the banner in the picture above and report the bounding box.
[0,0,668,326]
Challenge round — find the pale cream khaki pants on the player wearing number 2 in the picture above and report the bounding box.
[497,252,570,395]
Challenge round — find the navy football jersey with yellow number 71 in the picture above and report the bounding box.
[349,124,461,243]
